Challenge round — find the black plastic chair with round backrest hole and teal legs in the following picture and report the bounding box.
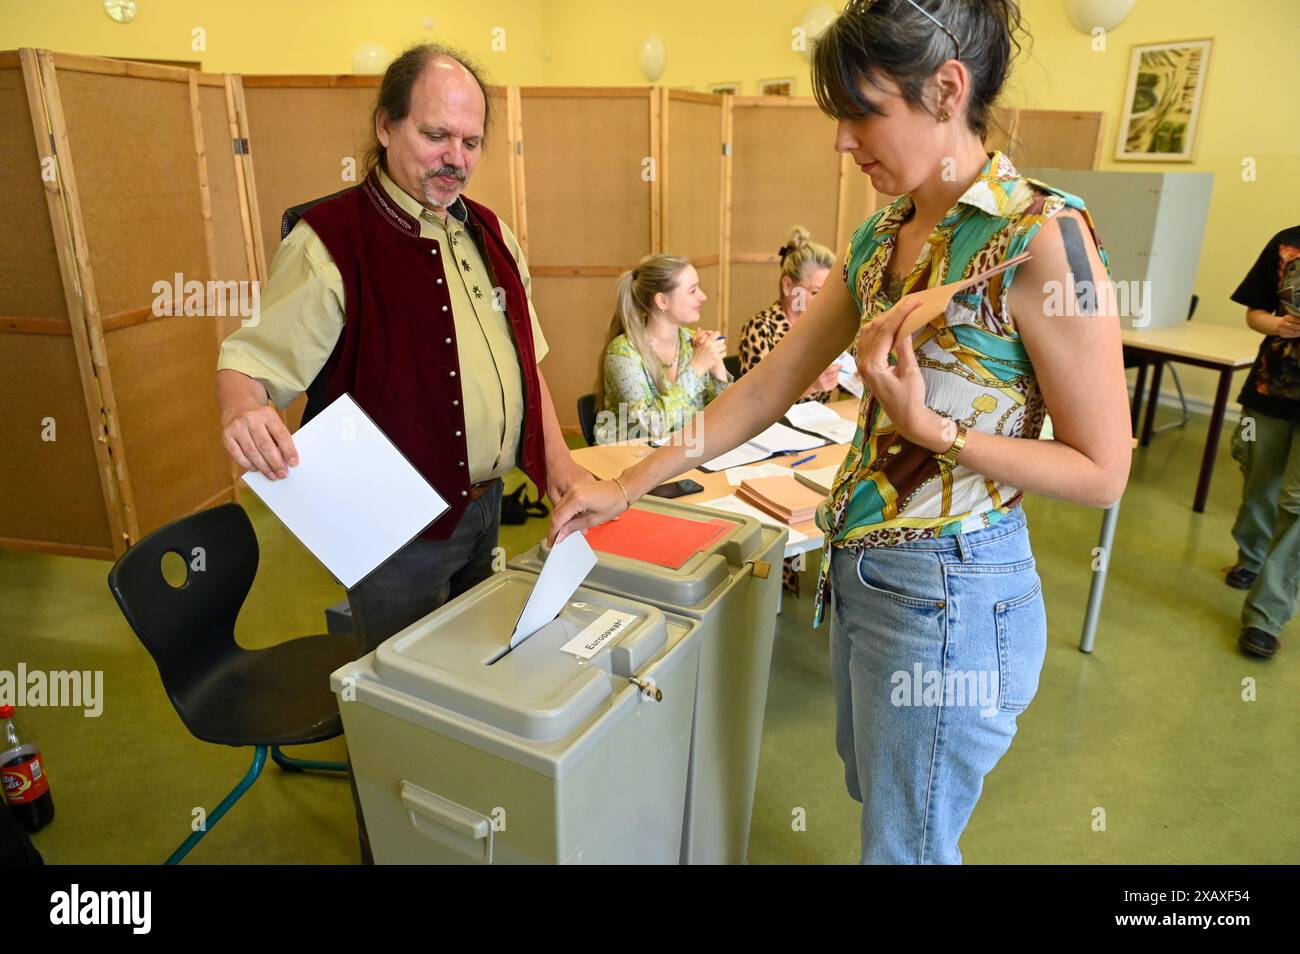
[108,503,358,864]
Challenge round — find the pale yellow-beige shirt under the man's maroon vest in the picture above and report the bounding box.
[217,169,547,483]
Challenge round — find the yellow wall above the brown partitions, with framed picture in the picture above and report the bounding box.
[0,0,1300,408]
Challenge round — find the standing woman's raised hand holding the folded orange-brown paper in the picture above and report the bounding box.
[857,298,953,454]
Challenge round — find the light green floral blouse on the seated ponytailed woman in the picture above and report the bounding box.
[595,328,732,445]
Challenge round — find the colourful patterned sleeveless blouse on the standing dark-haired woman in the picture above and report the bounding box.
[813,152,1110,626]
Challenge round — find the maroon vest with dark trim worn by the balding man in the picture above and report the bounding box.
[303,172,546,539]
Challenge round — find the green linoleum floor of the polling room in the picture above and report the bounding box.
[0,417,1300,863]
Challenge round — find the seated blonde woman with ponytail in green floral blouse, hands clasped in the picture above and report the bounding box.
[595,255,732,443]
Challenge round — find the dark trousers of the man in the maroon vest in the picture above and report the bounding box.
[347,481,502,864]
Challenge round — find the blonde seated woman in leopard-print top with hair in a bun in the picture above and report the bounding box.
[740,225,840,404]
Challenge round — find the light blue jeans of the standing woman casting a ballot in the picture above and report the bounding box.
[831,507,1047,864]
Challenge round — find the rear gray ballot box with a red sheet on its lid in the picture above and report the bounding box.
[510,496,789,864]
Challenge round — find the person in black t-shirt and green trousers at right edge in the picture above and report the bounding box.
[1226,225,1300,659]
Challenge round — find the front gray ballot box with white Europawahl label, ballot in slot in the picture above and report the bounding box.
[330,571,699,864]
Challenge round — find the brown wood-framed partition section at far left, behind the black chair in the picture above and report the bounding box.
[0,49,248,558]
